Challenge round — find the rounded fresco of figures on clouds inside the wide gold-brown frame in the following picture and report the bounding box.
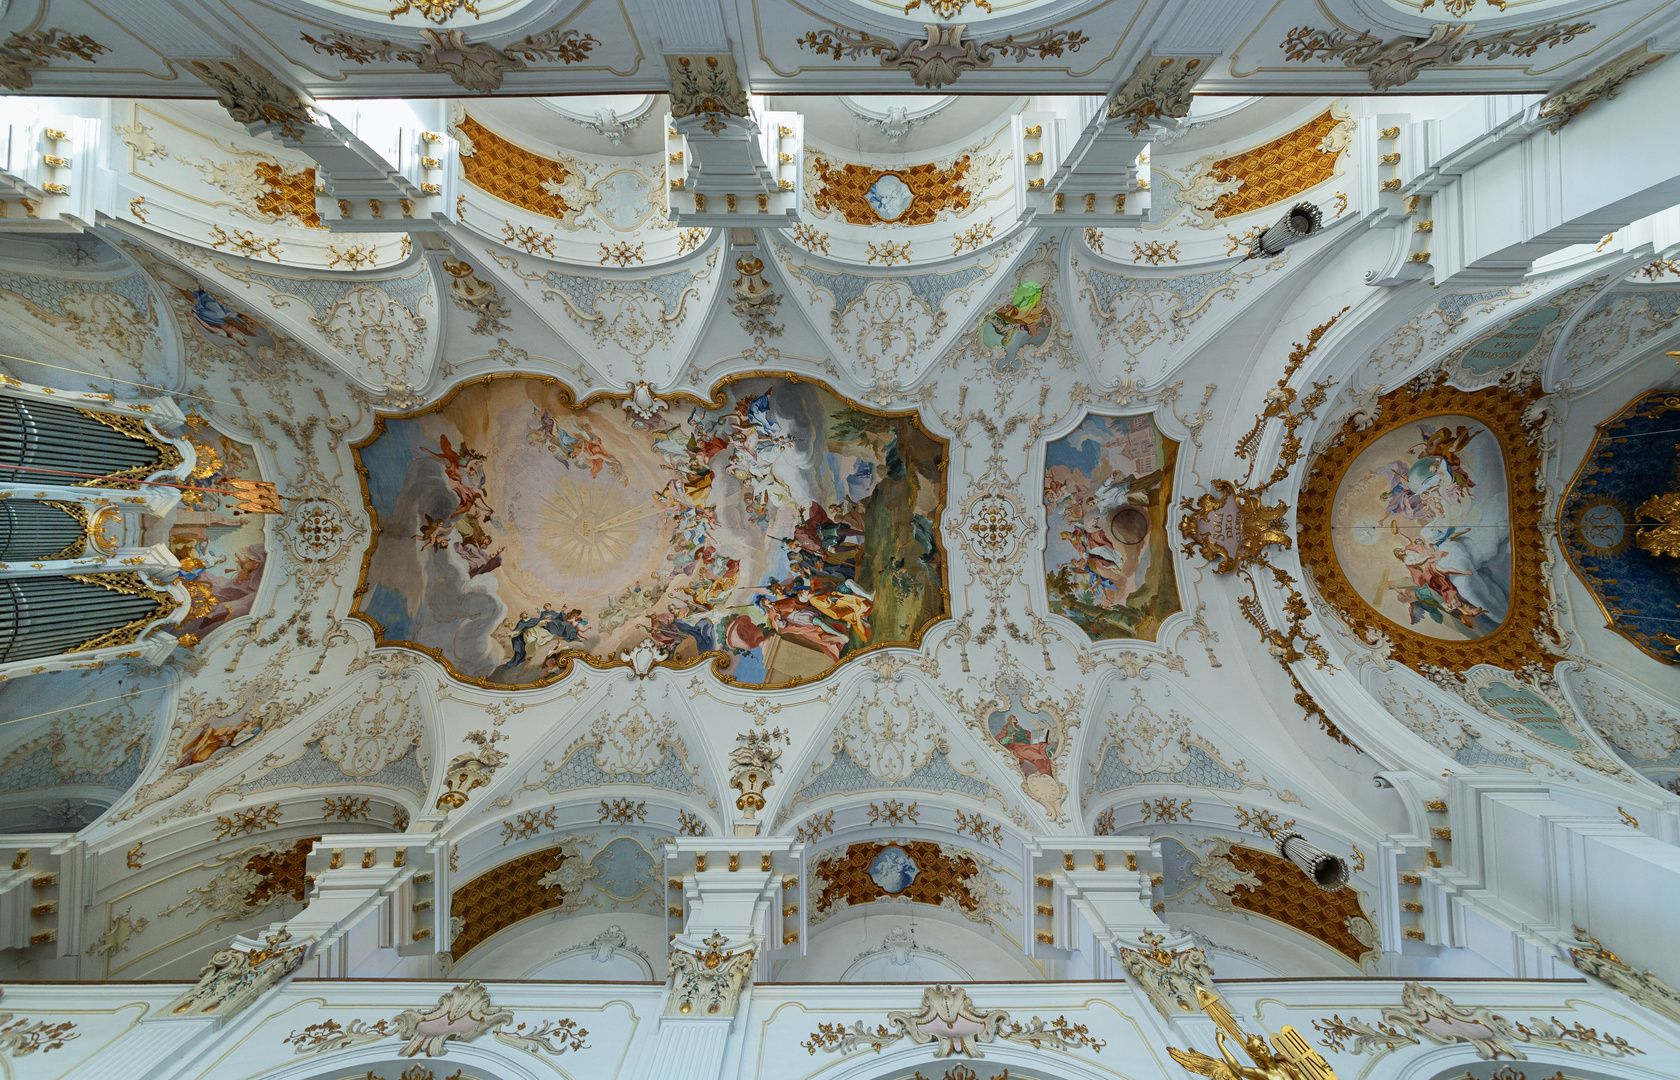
[1331,415,1512,640]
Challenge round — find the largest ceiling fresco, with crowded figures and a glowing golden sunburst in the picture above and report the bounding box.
[356,376,949,687]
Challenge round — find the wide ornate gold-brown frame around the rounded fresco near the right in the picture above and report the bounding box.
[1295,373,1557,677]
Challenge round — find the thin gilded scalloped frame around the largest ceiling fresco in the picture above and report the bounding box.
[349,371,951,690]
